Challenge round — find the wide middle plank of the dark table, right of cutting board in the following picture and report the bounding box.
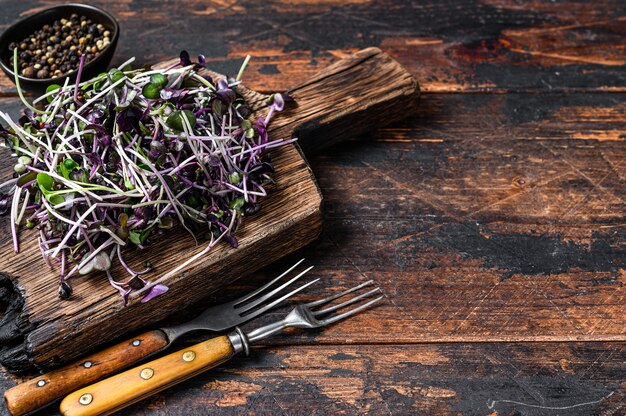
[184,94,626,344]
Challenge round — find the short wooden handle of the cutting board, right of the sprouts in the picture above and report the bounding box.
[272,48,419,156]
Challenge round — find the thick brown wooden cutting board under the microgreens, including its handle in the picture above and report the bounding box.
[0,48,419,372]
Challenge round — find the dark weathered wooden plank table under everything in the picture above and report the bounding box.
[0,0,626,415]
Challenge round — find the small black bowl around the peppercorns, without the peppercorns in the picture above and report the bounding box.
[0,3,120,93]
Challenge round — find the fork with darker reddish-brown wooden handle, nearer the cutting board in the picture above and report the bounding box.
[4,259,319,416]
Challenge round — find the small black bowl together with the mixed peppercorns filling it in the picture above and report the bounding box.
[0,4,119,93]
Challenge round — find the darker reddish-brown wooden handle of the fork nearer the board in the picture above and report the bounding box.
[4,329,169,416]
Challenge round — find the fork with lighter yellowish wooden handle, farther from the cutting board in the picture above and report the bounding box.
[61,280,383,416]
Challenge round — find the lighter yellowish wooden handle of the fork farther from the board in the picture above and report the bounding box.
[61,335,235,416]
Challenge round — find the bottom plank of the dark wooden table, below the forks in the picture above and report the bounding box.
[0,342,626,416]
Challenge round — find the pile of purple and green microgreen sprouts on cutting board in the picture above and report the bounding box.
[0,51,293,303]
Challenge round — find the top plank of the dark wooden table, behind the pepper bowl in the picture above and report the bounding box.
[0,0,626,93]
